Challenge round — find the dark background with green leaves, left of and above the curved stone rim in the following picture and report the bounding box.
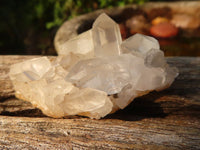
[0,0,148,54]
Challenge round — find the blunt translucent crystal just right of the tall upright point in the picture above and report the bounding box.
[121,33,160,56]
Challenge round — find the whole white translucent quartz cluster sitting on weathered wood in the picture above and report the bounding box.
[9,14,178,119]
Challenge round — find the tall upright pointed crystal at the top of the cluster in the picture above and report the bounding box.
[92,13,122,57]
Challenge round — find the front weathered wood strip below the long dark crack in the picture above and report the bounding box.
[0,117,199,149]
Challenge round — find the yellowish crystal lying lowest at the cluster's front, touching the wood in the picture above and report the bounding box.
[60,88,113,119]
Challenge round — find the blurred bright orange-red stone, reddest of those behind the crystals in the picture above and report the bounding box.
[150,22,178,38]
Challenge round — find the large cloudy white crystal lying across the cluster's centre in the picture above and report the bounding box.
[66,54,142,95]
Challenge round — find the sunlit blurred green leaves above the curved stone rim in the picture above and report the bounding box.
[35,0,148,29]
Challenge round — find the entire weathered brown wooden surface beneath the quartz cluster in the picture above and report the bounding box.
[0,56,200,150]
